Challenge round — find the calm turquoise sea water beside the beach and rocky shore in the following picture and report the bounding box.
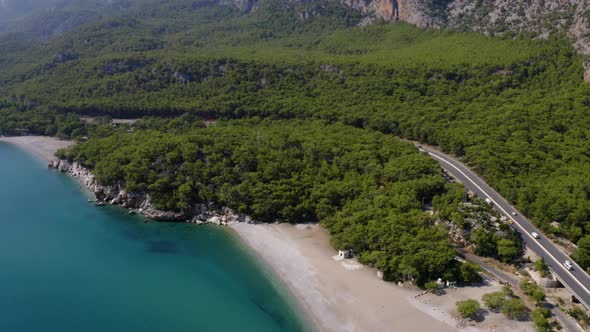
[0,143,308,332]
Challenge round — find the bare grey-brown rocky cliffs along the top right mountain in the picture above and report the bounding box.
[220,0,590,81]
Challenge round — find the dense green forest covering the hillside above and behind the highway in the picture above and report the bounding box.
[0,17,590,244]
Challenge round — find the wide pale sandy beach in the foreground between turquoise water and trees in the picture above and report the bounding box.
[232,223,500,331]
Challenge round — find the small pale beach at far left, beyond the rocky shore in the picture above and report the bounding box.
[0,136,75,161]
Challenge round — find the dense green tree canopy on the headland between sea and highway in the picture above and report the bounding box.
[59,120,480,285]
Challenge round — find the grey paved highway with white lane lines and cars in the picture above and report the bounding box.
[419,146,590,310]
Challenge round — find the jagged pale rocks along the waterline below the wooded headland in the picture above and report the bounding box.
[48,159,254,225]
